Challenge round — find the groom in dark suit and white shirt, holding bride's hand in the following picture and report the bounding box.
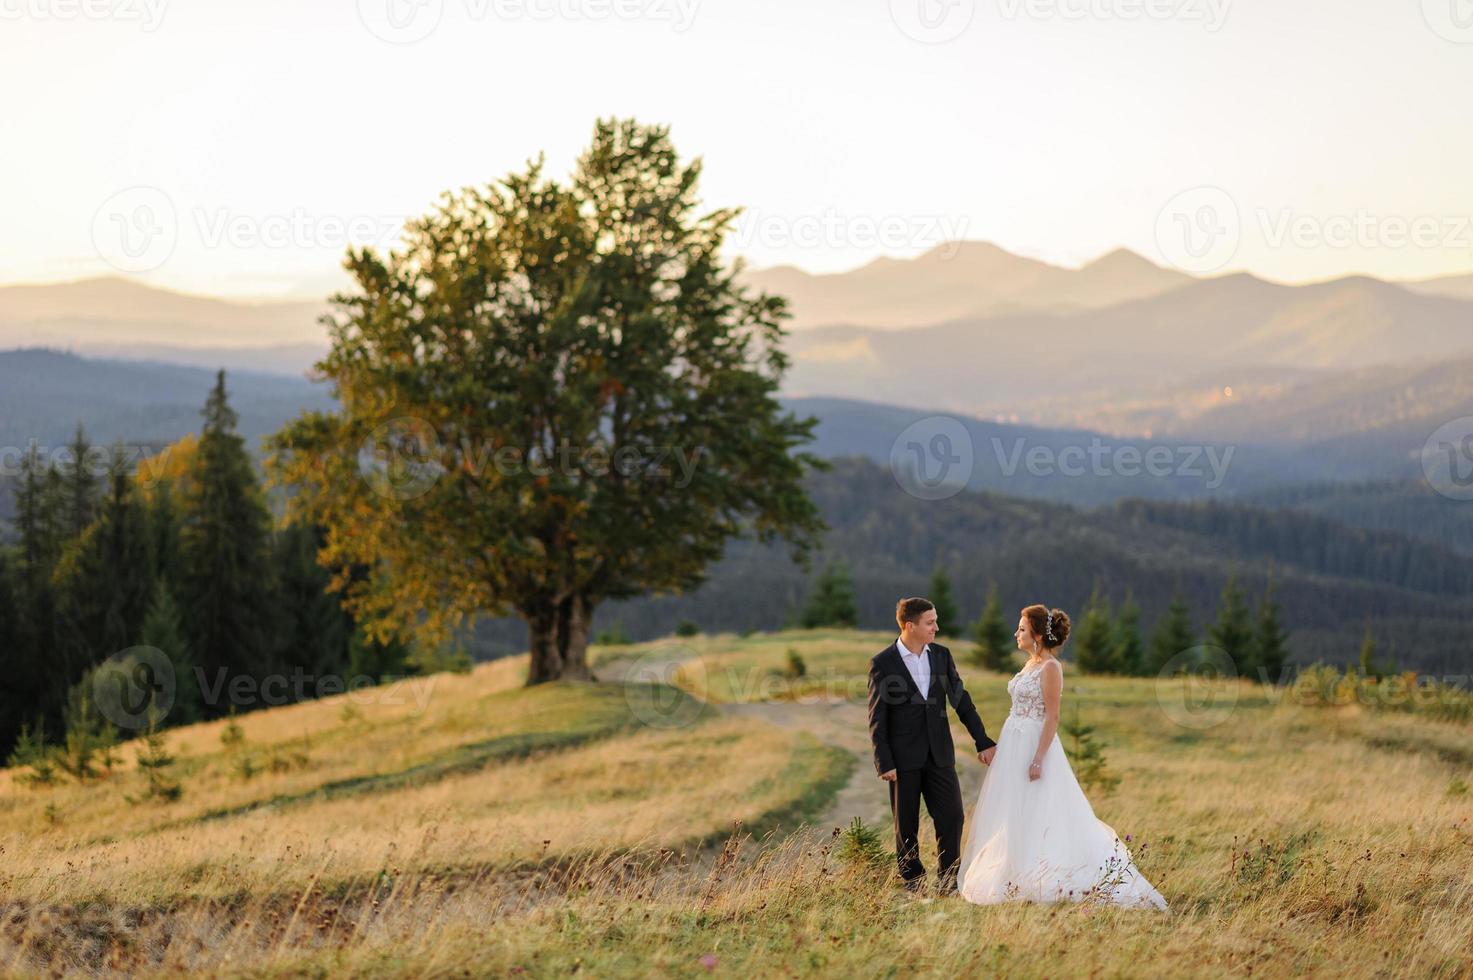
[869,598,997,895]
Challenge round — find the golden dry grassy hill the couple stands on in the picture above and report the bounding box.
[0,631,1473,977]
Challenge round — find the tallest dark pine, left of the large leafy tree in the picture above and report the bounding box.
[178,371,273,704]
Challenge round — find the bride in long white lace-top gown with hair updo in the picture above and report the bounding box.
[957,606,1167,909]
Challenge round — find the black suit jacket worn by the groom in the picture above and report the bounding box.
[869,640,997,775]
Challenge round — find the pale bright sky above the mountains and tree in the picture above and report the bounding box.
[0,0,1473,295]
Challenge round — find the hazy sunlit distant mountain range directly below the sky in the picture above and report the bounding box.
[0,242,1473,441]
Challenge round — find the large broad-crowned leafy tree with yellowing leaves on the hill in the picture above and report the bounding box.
[268,119,822,684]
